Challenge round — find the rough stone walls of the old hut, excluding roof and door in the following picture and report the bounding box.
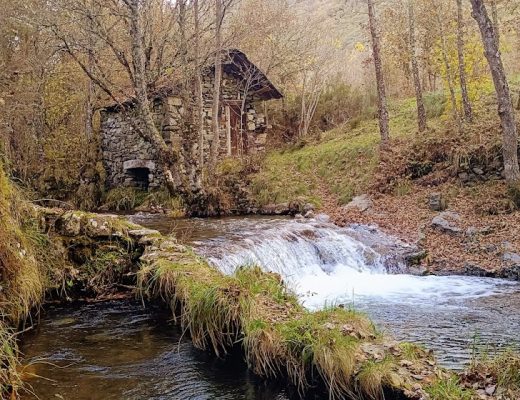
[101,73,267,189]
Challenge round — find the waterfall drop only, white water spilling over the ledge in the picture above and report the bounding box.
[201,220,404,279]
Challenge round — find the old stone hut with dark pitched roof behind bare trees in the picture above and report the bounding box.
[101,50,282,190]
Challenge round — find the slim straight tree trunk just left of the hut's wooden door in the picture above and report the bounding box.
[211,0,222,167]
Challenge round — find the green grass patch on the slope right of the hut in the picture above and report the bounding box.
[252,95,444,205]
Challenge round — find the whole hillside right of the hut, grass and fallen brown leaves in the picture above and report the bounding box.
[251,82,520,279]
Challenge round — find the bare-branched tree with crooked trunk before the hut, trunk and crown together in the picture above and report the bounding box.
[42,0,187,194]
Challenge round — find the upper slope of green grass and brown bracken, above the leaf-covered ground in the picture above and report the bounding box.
[252,77,520,206]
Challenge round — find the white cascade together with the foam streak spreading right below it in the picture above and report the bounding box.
[194,219,517,309]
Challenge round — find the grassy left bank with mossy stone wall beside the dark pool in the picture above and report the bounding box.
[0,165,147,398]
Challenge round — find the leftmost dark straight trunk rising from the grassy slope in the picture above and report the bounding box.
[367,0,390,147]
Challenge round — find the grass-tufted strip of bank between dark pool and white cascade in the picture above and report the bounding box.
[139,238,443,399]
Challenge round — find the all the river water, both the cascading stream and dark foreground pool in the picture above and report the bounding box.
[22,215,520,400]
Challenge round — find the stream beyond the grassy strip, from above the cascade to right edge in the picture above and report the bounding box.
[134,214,520,369]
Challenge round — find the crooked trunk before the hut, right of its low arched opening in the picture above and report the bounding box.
[125,0,183,194]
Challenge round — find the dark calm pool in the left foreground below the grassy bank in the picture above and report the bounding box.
[22,301,289,400]
